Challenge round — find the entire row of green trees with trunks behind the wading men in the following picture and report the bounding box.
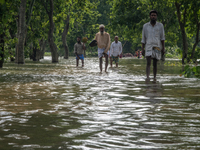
[0,0,200,68]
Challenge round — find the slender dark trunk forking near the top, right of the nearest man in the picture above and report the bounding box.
[175,2,188,64]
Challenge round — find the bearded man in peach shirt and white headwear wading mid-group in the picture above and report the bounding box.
[95,24,110,73]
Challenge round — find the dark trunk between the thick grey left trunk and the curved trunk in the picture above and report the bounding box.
[46,0,58,63]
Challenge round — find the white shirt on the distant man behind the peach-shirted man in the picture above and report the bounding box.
[110,41,122,57]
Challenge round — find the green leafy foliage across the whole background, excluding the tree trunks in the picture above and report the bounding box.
[0,0,200,68]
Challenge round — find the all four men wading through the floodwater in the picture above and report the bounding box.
[74,10,165,79]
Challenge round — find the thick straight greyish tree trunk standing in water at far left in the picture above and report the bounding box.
[15,0,26,64]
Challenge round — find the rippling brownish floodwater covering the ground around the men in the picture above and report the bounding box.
[0,57,200,150]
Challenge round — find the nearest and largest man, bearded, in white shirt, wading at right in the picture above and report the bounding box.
[141,10,165,79]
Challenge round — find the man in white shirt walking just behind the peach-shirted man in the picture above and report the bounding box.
[110,36,122,68]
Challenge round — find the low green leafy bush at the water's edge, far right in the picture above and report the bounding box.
[182,65,200,78]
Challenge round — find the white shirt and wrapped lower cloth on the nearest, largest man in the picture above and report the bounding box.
[141,22,165,59]
